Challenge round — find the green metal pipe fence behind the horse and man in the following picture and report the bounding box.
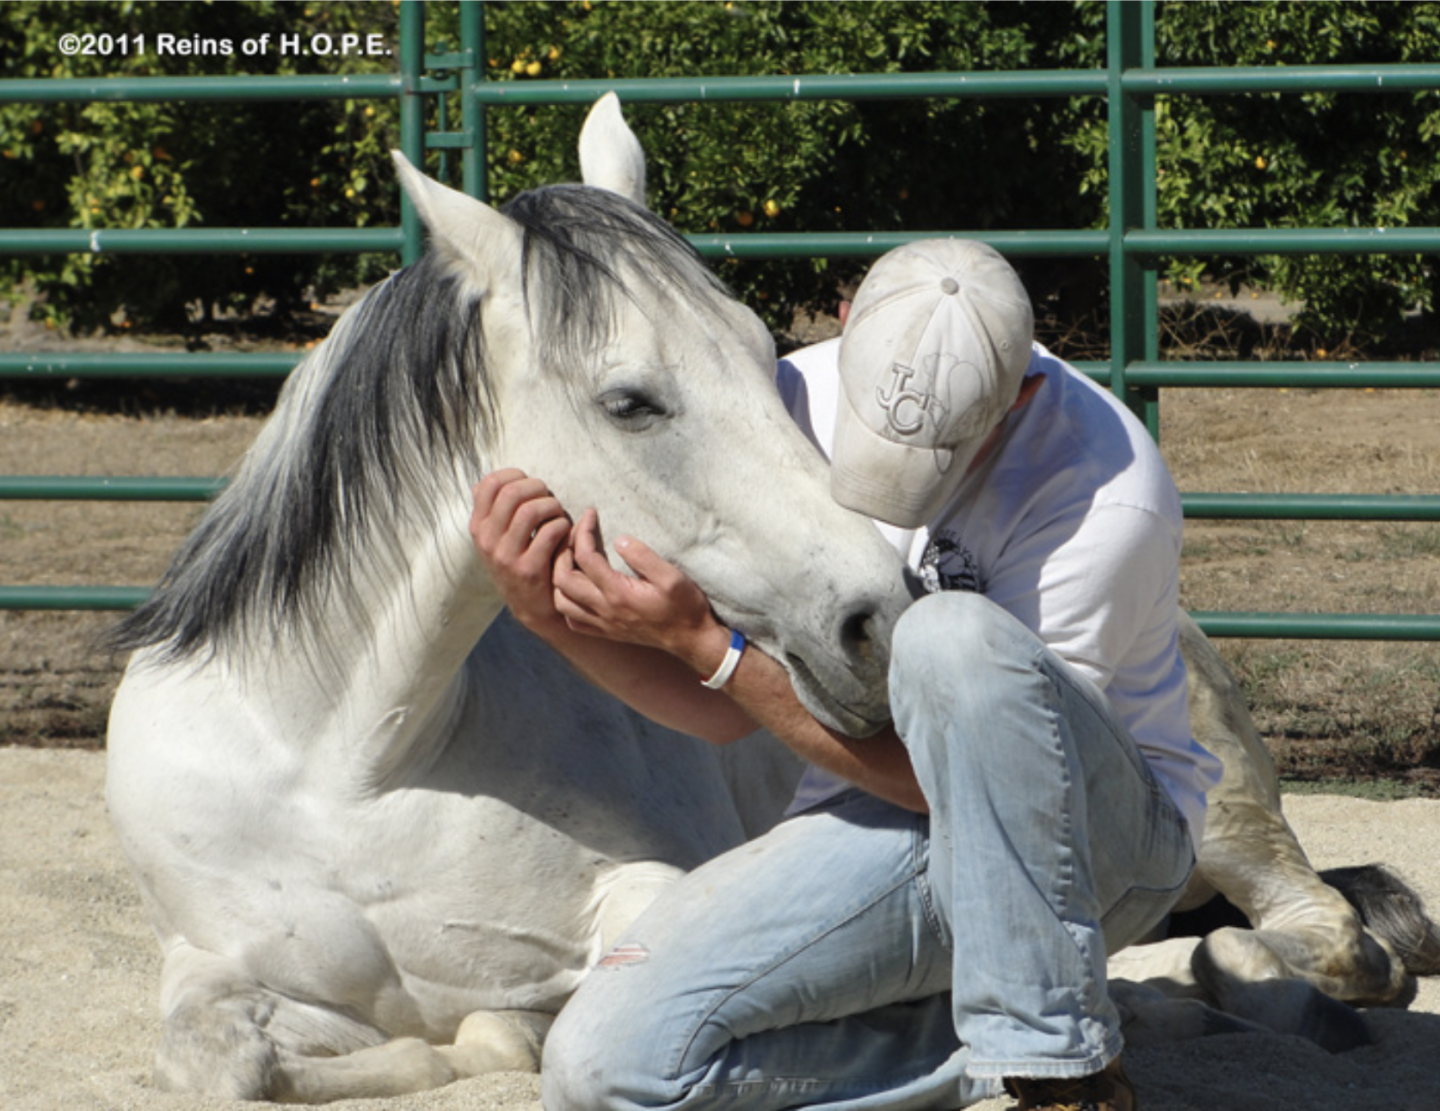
[0,0,1440,640]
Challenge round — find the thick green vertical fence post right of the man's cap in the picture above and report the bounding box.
[1106,0,1159,436]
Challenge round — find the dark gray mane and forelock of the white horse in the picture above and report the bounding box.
[107,186,721,659]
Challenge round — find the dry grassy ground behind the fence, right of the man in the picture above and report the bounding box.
[1161,390,1440,790]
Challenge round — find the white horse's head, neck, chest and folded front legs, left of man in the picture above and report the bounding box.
[107,96,909,1102]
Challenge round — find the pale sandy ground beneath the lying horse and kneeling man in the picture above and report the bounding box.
[0,748,1440,1111]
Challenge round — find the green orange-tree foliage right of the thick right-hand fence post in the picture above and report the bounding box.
[1156,0,1440,345]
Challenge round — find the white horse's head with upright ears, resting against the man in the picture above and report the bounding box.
[400,96,909,733]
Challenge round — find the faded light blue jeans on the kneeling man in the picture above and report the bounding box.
[543,593,1194,1111]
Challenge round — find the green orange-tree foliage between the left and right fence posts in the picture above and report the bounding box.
[455,1,1104,327]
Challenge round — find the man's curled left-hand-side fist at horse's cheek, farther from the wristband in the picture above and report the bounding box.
[469,468,570,638]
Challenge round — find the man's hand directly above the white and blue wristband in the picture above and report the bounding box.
[554,509,730,674]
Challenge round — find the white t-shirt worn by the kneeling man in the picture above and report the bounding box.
[778,340,1221,846]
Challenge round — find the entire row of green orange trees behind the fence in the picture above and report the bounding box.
[0,0,1440,344]
